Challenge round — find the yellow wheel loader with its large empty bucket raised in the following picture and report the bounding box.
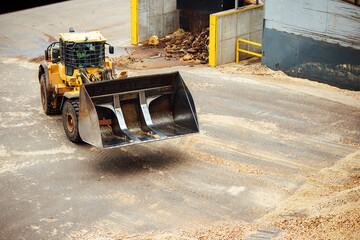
[38,28,199,148]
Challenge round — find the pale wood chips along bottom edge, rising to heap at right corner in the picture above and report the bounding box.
[72,150,360,240]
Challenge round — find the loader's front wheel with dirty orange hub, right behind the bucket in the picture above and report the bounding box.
[62,99,82,143]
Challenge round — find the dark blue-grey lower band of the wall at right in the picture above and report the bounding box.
[261,28,360,90]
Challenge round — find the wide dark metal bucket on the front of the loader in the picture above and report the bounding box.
[79,72,199,148]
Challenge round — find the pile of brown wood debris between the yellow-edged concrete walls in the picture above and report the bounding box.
[139,28,209,64]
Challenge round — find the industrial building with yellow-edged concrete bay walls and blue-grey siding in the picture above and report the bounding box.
[131,0,360,90]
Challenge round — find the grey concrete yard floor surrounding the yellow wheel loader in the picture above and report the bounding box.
[0,0,360,239]
